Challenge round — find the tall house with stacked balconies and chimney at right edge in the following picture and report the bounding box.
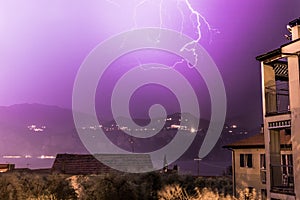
[256,18,300,200]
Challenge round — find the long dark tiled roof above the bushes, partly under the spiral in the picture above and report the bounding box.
[52,154,153,174]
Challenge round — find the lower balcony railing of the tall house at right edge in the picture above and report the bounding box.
[271,165,295,194]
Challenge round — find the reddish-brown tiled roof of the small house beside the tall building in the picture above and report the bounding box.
[224,131,291,149]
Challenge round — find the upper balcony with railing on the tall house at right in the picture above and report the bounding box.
[265,81,290,116]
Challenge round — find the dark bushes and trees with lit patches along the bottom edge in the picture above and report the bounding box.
[0,172,256,200]
